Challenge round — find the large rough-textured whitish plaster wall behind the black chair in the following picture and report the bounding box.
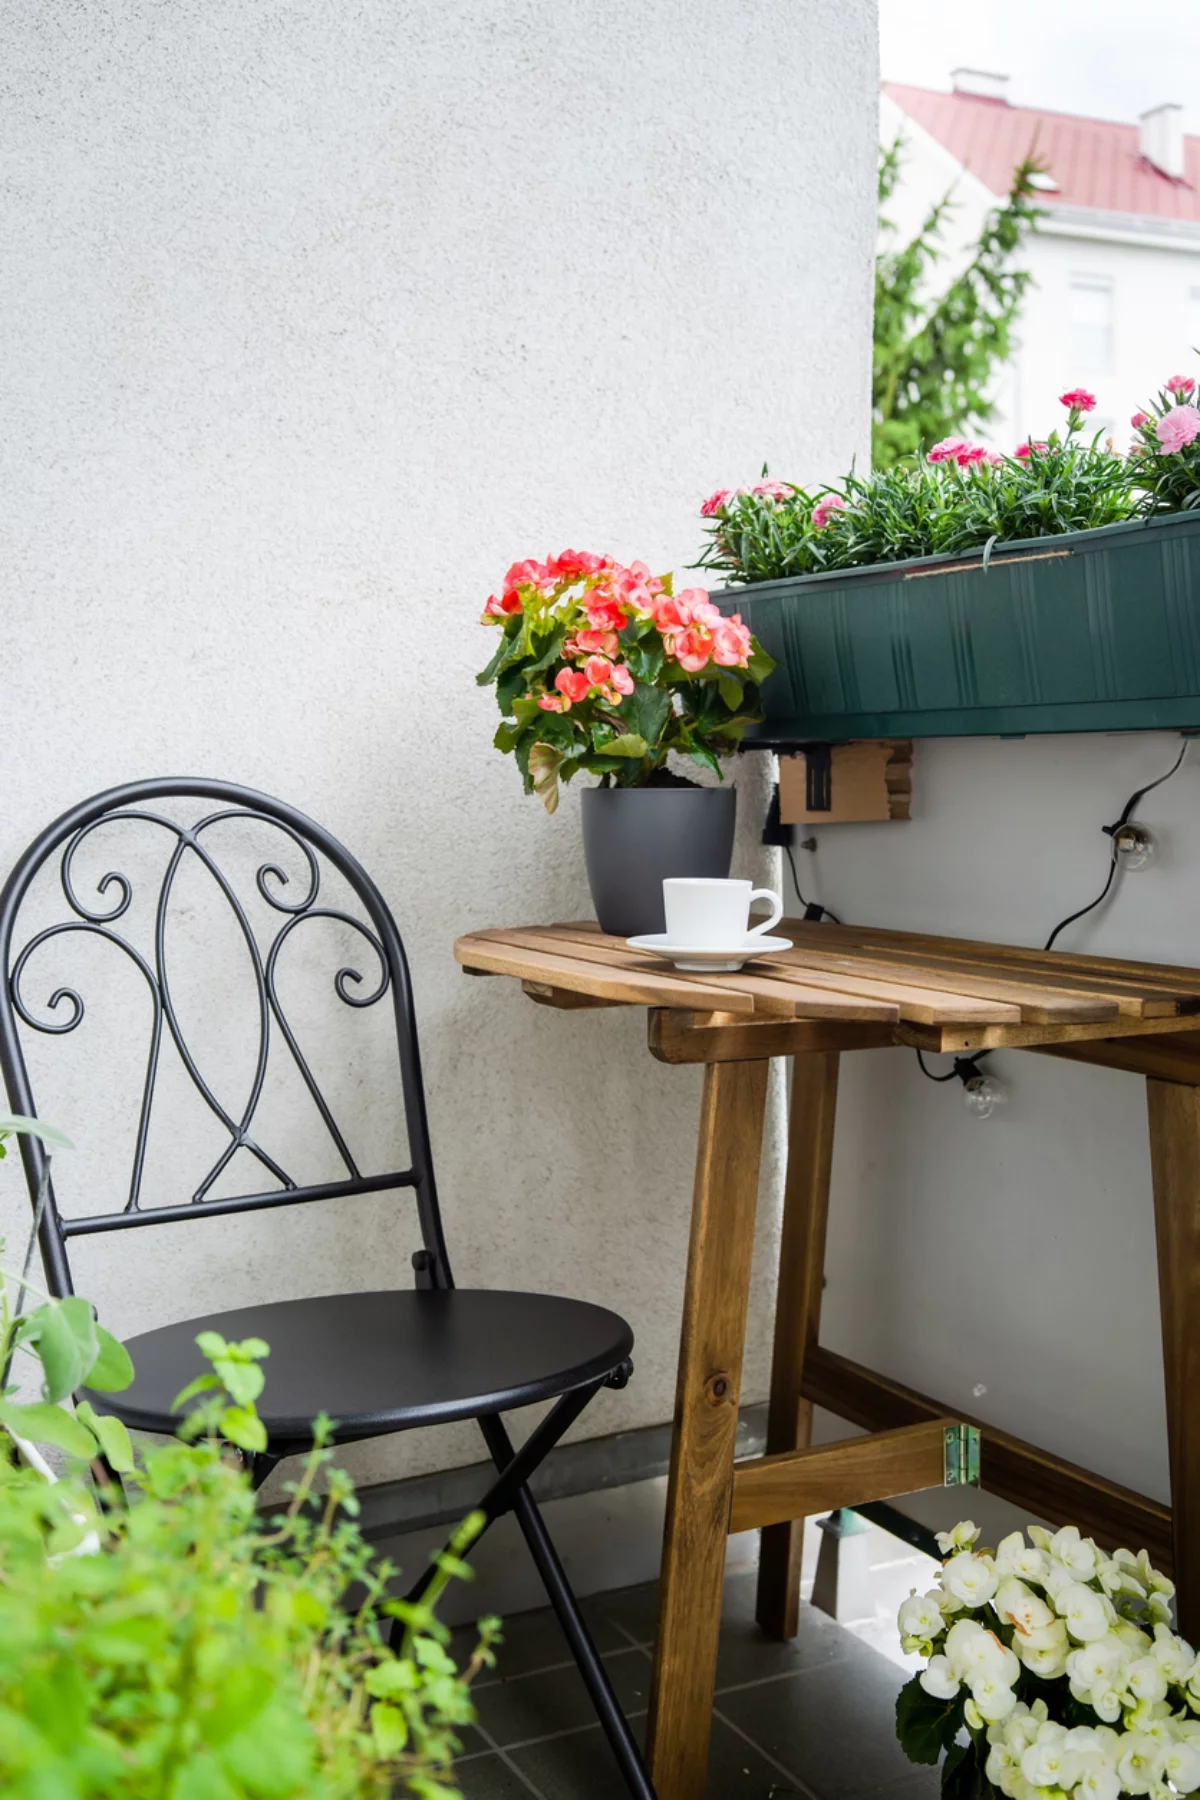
[0,0,876,1474]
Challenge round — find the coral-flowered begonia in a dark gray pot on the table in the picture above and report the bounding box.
[477,551,774,938]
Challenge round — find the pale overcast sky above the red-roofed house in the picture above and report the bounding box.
[880,0,1200,135]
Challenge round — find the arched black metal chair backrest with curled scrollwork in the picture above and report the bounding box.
[0,778,452,1294]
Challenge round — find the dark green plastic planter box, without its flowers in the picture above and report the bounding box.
[712,513,1200,747]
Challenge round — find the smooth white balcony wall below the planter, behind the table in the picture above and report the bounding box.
[797,733,1200,1521]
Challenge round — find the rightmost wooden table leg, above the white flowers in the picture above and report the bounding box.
[1132,1080,1200,1643]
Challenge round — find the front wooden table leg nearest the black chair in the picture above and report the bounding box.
[648,1060,770,1800]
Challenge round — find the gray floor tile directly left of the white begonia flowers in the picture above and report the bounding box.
[718,1649,912,1800]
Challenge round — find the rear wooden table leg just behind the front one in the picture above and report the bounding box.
[756,1055,838,1638]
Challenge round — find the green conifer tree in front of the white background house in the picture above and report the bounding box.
[871,139,1040,468]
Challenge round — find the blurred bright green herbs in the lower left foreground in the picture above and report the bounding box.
[0,1166,498,1800]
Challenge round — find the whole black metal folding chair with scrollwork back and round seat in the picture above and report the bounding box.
[0,779,653,1800]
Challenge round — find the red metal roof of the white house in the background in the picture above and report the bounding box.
[883,81,1200,221]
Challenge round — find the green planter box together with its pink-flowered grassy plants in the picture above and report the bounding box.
[702,376,1200,747]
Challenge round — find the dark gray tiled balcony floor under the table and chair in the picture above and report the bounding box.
[446,1568,939,1800]
